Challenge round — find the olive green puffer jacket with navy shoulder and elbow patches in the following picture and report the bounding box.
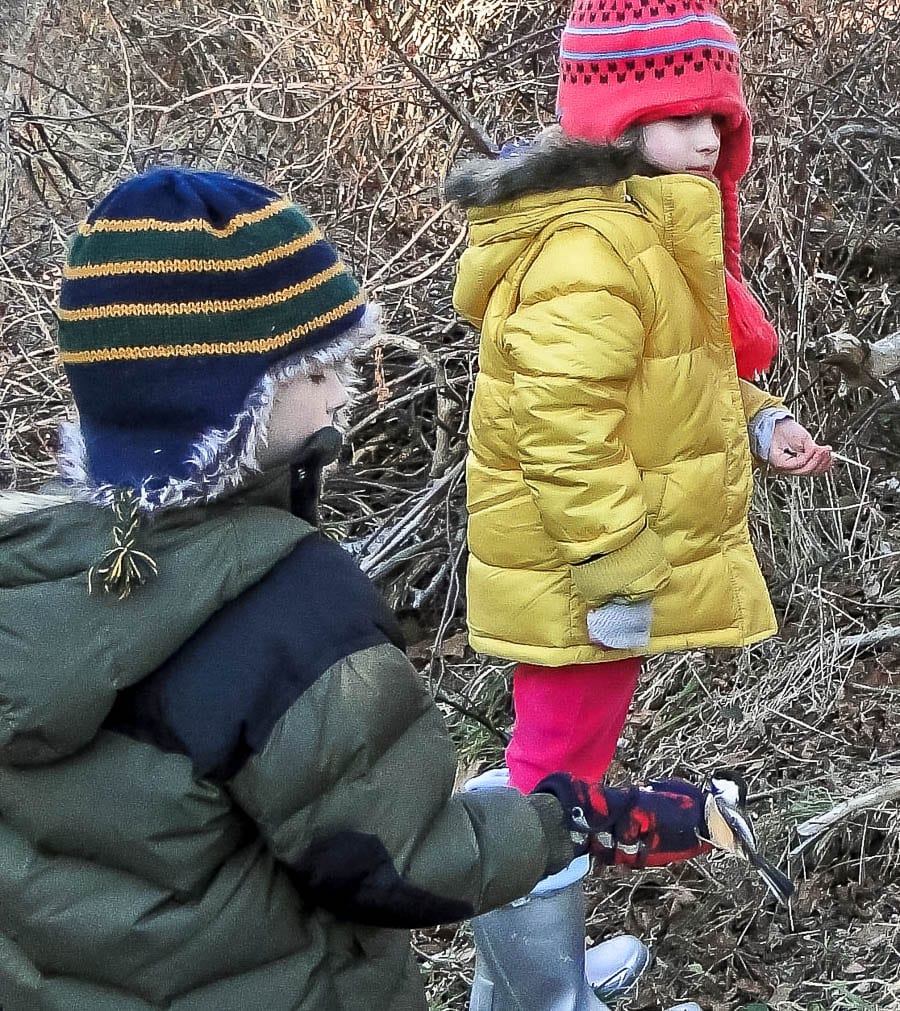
[0,475,571,1011]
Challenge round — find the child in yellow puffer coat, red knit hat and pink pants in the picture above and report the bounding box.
[448,0,831,1011]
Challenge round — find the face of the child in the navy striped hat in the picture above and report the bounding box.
[259,366,350,469]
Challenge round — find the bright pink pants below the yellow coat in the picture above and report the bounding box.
[507,657,641,793]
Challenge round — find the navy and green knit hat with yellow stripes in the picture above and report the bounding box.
[59,168,365,497]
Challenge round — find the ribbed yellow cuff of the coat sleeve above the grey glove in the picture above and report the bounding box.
[571,527,671,607]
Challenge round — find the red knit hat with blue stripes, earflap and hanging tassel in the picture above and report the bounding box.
[557,0,778,378]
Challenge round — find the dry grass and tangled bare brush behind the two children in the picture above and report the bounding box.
[0,0,900,1011]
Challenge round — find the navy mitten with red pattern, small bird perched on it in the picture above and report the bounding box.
[534,772,712,867]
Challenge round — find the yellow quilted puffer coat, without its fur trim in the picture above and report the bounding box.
[454,175,779,666]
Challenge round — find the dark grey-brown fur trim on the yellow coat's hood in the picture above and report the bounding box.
[444,127,657,209]
